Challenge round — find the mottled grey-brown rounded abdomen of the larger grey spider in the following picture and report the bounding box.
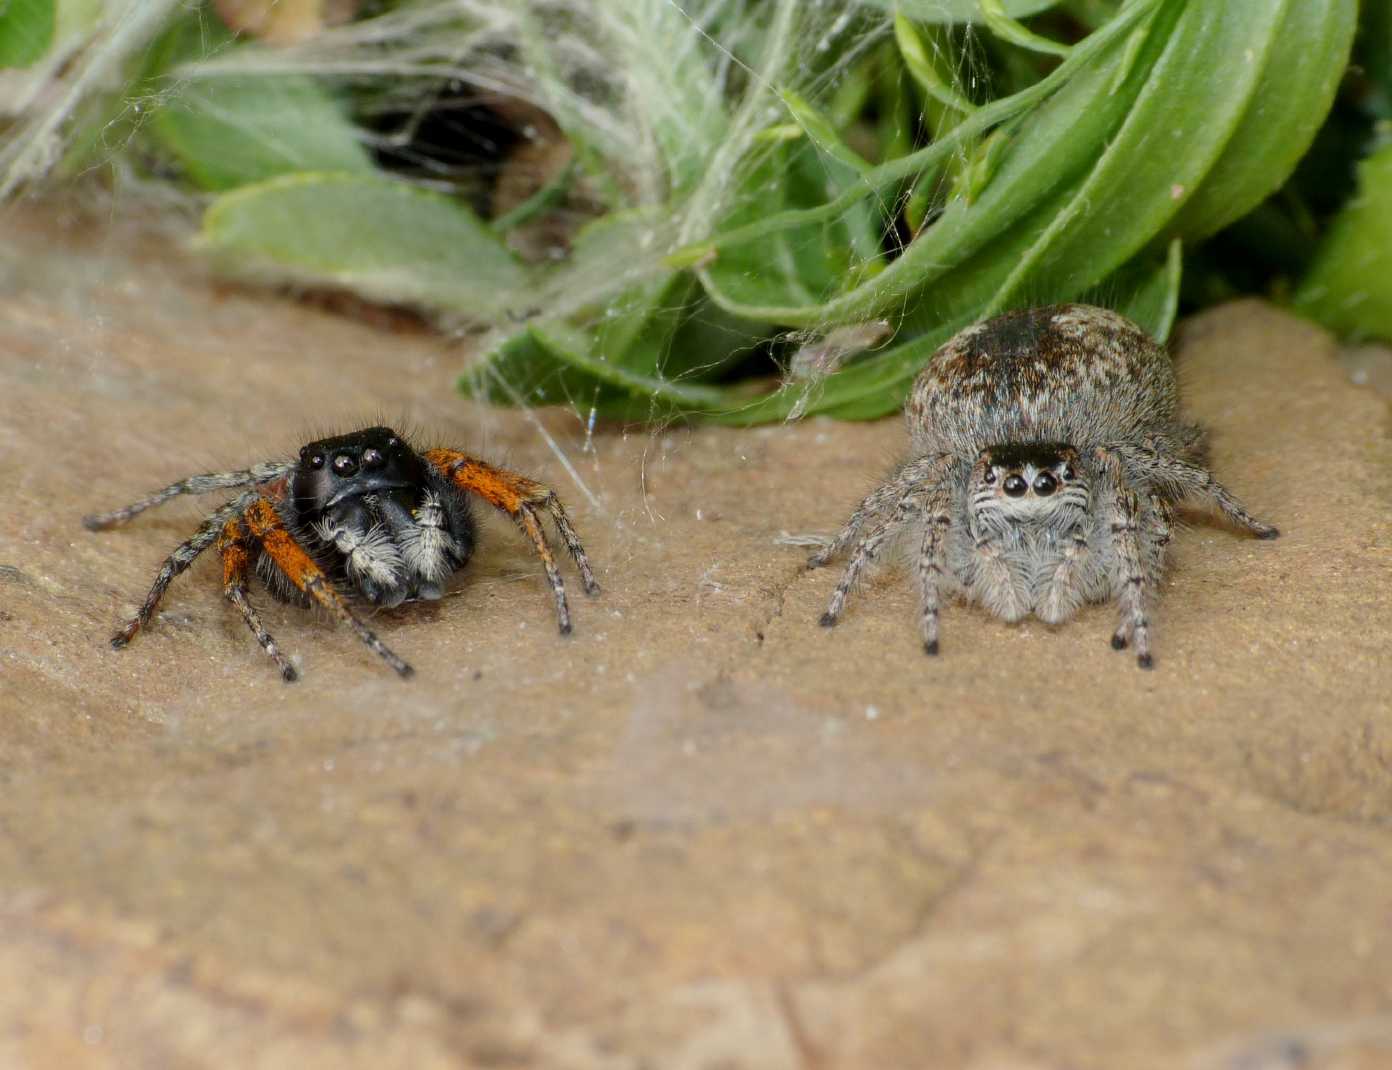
[905,305,1176,454]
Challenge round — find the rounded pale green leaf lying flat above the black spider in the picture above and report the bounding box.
[202,174,529,321]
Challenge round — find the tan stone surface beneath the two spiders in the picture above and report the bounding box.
[0,206,1392,1070]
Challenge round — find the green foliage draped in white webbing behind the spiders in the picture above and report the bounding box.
[0,0,1369,424]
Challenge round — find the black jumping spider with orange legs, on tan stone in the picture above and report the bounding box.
[84,427,599,680]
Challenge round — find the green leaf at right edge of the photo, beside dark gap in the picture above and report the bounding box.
[1295,145,1392,341]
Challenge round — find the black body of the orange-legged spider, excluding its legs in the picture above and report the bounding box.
[282,427,473,607]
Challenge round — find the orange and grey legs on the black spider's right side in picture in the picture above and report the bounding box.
[425,449,599,634]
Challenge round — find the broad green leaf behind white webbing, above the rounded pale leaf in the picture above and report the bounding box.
[146,15,373,191]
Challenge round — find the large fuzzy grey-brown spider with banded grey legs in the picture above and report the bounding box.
[809,305,1278,668]
